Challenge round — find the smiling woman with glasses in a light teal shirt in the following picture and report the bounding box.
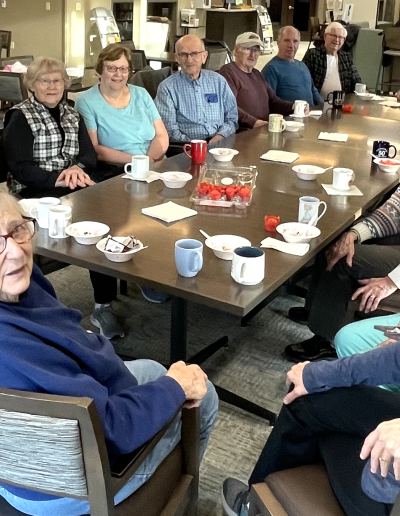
[75,43,168,172]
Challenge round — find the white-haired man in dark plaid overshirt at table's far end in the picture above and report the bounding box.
[303,22,362,100]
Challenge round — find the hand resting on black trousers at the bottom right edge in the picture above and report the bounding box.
[360,419,400,480]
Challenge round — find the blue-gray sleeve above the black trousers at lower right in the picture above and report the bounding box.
[303,342,400,394]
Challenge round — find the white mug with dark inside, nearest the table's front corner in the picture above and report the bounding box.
[231,247,265,285]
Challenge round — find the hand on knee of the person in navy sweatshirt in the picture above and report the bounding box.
[166,360,207,408]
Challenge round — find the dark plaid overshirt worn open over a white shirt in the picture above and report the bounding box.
[303,47,362,93]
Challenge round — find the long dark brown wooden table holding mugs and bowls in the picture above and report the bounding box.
[36,98,400,424]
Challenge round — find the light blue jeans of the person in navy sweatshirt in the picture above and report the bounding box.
[0,360,218,516]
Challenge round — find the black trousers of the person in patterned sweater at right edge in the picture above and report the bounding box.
[306,235,400,340]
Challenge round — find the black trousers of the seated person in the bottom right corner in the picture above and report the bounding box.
[249,386,400,516]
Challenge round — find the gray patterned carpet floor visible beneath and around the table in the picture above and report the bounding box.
[48,266,311,516]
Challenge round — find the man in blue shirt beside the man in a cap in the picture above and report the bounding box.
[261,26,324,106]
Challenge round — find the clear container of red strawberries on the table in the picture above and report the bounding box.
[191,164,257,209]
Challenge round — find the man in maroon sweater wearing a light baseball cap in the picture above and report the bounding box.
[219,32,293,129]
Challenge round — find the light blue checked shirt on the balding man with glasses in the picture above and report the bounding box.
[155,70,238,142]
